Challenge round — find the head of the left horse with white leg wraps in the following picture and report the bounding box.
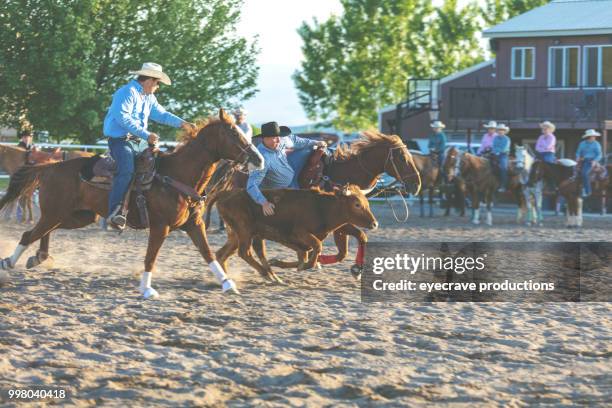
[200,109,264,170]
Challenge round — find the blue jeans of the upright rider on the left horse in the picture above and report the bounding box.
[108,137,136,215]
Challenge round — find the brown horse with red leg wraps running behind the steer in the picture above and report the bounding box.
[207,131,421,277]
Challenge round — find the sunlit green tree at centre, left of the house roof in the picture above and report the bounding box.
[294,0,483,130]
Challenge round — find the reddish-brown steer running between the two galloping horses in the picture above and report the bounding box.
[213,186,378,283]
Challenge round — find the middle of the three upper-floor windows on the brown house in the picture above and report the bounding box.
[548,47,580,88]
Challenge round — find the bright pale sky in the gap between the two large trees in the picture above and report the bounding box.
[237,0,342,126]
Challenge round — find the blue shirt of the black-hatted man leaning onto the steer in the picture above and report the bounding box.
[247,135,317,204]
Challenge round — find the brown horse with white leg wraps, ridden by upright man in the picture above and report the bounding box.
[0,109,263,299]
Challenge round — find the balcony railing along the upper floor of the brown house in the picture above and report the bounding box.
[449,86,612,123]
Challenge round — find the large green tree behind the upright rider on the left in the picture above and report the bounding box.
[0,0,258,142]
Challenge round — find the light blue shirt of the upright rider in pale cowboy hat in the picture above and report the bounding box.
[103,80,184,139]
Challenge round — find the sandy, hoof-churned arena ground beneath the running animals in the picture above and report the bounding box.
[0,205,612,407]
